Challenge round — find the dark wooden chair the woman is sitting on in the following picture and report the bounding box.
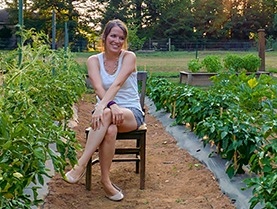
[86,71,147,190]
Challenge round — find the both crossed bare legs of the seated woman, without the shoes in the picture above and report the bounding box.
[66,108,137,185]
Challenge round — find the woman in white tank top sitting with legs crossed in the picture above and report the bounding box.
[63,19,144,201]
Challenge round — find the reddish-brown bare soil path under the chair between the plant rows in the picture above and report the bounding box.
[42,95,235,209]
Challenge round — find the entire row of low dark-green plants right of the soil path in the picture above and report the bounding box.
[147,72,277,209]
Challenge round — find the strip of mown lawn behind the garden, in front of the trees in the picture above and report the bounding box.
[75,51,277,78]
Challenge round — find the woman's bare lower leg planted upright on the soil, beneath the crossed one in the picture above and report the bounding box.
[99,125,118,196]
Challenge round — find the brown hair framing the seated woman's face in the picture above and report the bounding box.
[101,19,128,51]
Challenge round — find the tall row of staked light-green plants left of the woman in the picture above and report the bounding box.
[0,31,85,209]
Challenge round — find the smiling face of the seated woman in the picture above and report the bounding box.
[105,26,125,52]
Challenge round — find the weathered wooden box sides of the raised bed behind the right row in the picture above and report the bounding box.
[180,71,271,86]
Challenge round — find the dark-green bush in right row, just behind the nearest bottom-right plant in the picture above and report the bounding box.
[195,108,262,178]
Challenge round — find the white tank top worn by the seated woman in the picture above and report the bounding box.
[97,51,142,112]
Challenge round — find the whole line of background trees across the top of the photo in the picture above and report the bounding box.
[2,0,277,49]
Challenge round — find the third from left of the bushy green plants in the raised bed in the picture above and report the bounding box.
[223,54,243,72]
